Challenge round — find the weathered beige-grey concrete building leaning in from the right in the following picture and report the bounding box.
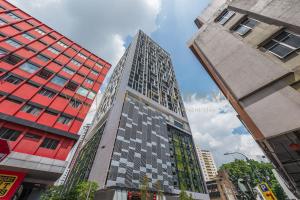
[189,0,300,196]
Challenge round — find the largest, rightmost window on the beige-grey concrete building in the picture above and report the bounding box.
[263,31,300,58]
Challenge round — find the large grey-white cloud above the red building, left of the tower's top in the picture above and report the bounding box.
[10,0,162,65]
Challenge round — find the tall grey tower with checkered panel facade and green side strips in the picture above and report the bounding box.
[66,31,209,199]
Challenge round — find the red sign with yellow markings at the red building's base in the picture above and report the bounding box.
[0,170,25,200]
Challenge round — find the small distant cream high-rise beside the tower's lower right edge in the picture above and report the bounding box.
[196,146,218,182]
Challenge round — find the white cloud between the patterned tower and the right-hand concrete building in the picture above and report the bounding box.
[184,94,263,166]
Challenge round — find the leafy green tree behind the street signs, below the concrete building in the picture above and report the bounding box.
[220,160,286,200]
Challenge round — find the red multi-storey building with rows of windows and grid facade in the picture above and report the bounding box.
[0,0,110,200]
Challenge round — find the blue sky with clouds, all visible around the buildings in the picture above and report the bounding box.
[10,0,262,166]
